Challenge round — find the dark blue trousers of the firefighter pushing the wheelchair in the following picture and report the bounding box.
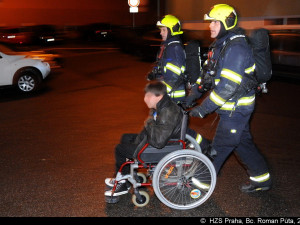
[212,112,269,184]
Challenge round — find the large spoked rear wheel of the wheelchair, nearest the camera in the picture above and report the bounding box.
[152,149,217,210]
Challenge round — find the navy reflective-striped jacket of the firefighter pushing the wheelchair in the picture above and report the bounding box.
[195,32,255,117]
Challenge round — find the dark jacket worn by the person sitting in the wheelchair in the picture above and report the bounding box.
[135,94,183,150]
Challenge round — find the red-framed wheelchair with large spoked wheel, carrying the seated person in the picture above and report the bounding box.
[105,111,216,210]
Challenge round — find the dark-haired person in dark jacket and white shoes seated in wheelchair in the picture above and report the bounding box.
[105,81,209,196]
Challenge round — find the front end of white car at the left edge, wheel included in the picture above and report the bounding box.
[0,48,51,93]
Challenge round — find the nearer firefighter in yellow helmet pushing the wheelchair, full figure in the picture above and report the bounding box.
[190,4,271,193]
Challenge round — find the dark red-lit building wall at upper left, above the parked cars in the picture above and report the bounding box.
[0,0,163,26]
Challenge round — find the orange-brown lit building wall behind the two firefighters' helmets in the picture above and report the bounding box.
[165,0,300,30]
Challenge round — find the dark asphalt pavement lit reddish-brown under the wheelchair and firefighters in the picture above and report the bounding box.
[0,43,300,219]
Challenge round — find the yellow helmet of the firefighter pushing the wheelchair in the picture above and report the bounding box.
[204,4,237,30]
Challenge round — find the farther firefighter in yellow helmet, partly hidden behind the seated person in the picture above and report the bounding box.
[148,15,186,103]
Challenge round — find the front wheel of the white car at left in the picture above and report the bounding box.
[17,69,41,93]
